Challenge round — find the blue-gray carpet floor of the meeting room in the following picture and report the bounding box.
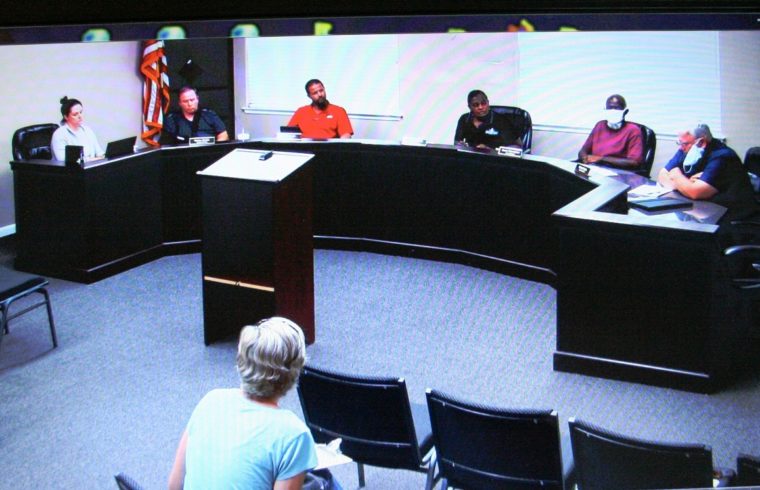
[0,250,760,489]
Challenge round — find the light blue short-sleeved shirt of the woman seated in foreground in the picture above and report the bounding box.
[184,389,317,490]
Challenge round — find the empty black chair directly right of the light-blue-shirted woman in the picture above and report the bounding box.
[298,366,435,489]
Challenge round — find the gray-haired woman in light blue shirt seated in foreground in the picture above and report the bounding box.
[169,317,317,490]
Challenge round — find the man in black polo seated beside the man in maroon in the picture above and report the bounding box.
[454,90,522,149]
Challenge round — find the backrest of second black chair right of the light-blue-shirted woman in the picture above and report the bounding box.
[427,390,563,489]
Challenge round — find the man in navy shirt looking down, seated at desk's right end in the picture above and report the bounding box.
[657,124,758,219]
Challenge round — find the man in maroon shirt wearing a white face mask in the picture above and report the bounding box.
[578,94,644,170]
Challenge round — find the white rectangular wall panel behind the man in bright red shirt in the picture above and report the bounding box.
[245,35,403,118]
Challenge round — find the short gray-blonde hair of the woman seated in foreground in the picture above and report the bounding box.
[237,316,306,398]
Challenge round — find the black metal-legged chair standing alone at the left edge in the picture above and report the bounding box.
[0,267,58,347]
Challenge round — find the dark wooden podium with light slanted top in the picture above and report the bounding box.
[198,149,314,345]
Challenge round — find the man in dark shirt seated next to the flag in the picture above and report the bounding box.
[161,87,230,144]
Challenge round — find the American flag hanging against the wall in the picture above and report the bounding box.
[140,40,169,146]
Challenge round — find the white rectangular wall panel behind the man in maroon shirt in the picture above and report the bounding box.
[519,31,721,134]
